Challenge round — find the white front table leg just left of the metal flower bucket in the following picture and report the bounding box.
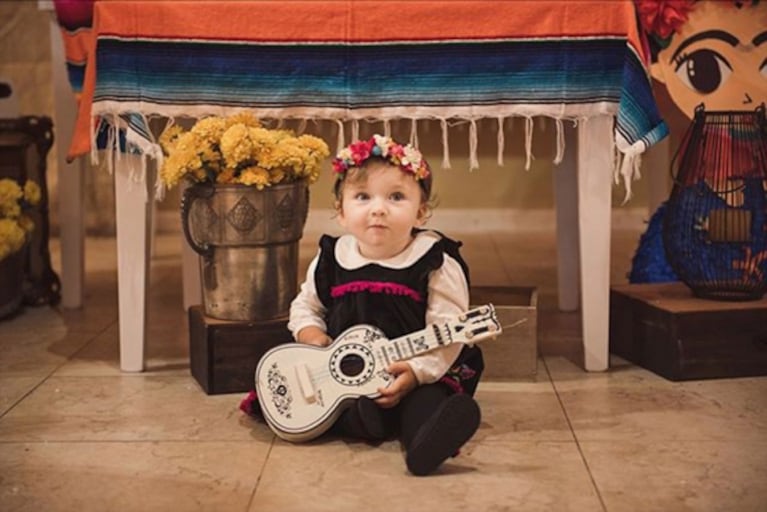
[114,154,154,372]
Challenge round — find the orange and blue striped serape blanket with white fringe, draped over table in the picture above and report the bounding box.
[58,0,667,196]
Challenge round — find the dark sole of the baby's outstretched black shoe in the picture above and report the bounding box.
[405,393,480,476]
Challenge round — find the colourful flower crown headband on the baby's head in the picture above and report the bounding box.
[333,135,430,180]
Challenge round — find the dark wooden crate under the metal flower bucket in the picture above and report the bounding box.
[189,306,293,395]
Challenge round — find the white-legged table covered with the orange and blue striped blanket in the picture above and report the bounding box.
[63,0,667,371]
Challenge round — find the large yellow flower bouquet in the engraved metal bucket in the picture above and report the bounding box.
[160,113,330,190]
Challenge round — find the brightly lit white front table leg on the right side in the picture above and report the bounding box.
[578,116,613,371]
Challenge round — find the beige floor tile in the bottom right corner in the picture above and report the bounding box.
[581,437,767,512]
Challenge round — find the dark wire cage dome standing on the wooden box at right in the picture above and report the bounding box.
[663,104,767,300]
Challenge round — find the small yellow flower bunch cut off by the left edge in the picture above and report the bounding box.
[0,178,40,261]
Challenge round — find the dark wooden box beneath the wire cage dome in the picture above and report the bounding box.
[610,283,767,381]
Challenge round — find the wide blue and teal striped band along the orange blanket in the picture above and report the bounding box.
[94,37,665,149]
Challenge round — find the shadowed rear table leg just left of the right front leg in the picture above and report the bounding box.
[554,123,580,311]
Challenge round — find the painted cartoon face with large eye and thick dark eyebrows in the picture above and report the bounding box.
[652,1,767,118]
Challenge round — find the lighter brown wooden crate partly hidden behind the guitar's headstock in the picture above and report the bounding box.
[471,286,538,381]
